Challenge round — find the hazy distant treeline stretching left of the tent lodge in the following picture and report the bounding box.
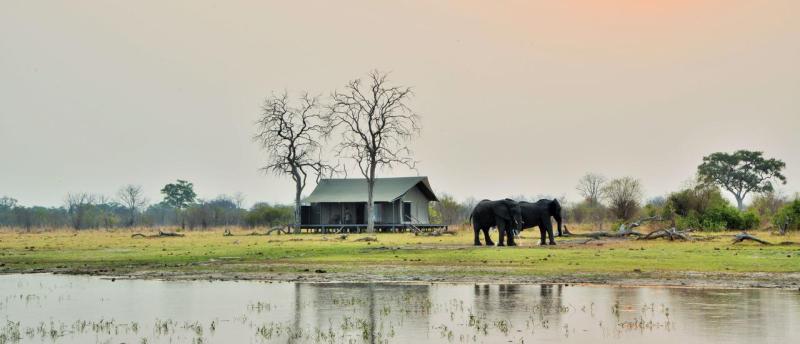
[0,183,294,231]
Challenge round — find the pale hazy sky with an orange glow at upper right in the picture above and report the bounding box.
[0,0,800,205]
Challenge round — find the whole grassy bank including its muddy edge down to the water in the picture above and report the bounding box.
[0,229,800,289]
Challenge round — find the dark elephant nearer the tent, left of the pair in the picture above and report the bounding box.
[469,198,522,246]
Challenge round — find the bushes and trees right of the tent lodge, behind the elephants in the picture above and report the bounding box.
[431,150,800,233]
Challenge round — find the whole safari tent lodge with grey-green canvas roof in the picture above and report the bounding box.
[300,177,446,232]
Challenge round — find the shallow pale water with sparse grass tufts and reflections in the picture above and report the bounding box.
[0,274,800,344]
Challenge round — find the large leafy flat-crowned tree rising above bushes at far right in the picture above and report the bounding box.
[697,150,786,210]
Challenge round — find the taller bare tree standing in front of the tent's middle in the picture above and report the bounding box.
[327,71,419,233]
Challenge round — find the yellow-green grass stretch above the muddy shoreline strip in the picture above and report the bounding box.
[0,230,800,276]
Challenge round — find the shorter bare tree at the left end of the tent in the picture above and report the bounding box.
[254,93,335,232]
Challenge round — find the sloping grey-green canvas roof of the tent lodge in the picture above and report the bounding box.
[305,177,437,203]
